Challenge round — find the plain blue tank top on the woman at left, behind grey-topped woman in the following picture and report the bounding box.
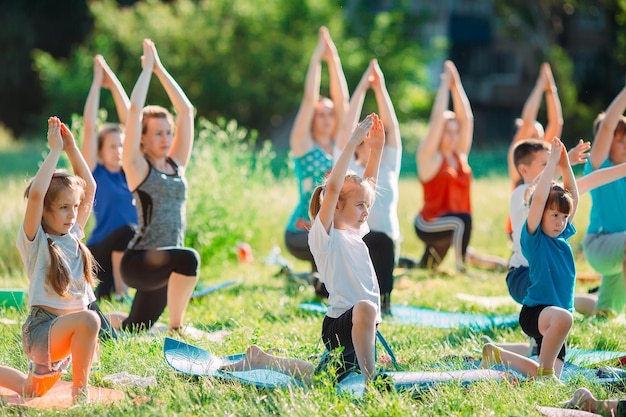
[87,164,137,246]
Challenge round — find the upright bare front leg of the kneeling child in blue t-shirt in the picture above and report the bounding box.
[538,307,574,371]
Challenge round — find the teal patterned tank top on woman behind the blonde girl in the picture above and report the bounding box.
[287,145,333,232]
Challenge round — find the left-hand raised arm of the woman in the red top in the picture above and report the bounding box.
[417,67,451,182]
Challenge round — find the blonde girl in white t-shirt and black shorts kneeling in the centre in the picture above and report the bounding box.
[223,114,385,383]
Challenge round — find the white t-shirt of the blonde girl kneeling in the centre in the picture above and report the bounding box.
[309,216,381,323]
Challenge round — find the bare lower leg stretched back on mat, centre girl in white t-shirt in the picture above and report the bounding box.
[220,345,315,384]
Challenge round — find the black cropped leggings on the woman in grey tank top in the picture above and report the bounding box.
[121,247,200,331]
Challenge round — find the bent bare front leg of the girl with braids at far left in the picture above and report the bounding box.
[50,310,100,394]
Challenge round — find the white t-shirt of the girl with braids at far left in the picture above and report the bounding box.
[16,225,96,309]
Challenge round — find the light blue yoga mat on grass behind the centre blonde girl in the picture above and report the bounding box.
[299,303,519,330]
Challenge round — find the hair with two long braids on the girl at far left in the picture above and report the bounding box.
[24,170,97,297]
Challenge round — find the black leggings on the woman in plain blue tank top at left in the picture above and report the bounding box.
[89,224,135,300]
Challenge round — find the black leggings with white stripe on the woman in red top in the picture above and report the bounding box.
[415,213,472,270]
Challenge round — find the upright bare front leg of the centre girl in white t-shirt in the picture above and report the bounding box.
[352,300,376,381]
